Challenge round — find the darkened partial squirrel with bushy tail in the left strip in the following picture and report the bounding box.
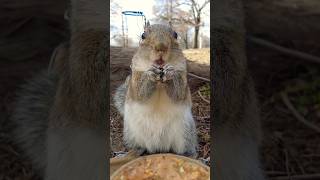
[11,0,109,180]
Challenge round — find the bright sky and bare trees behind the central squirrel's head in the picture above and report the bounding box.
[110,0,210,49]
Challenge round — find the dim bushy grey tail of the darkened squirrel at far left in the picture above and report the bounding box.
[10,71,58,174]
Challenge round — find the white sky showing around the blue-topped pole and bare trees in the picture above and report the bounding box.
[110,0,210,45]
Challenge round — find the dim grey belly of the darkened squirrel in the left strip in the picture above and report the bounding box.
[45,127,107,180]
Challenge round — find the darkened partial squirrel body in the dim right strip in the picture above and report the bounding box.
[211,0,265,180]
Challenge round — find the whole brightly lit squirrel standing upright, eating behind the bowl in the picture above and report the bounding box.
[113,24,197,157]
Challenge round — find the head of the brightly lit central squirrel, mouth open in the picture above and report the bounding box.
[140,24,179,66]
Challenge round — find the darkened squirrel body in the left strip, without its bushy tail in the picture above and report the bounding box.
[46,0,109,180]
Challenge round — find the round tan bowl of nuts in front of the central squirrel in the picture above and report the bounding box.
[111,154,210,180]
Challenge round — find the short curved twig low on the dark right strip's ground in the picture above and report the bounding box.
[281,92,320,133]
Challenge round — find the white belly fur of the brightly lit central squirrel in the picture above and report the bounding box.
[124,88,194,154]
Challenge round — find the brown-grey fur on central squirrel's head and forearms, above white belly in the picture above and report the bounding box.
[127,25,189,102]
